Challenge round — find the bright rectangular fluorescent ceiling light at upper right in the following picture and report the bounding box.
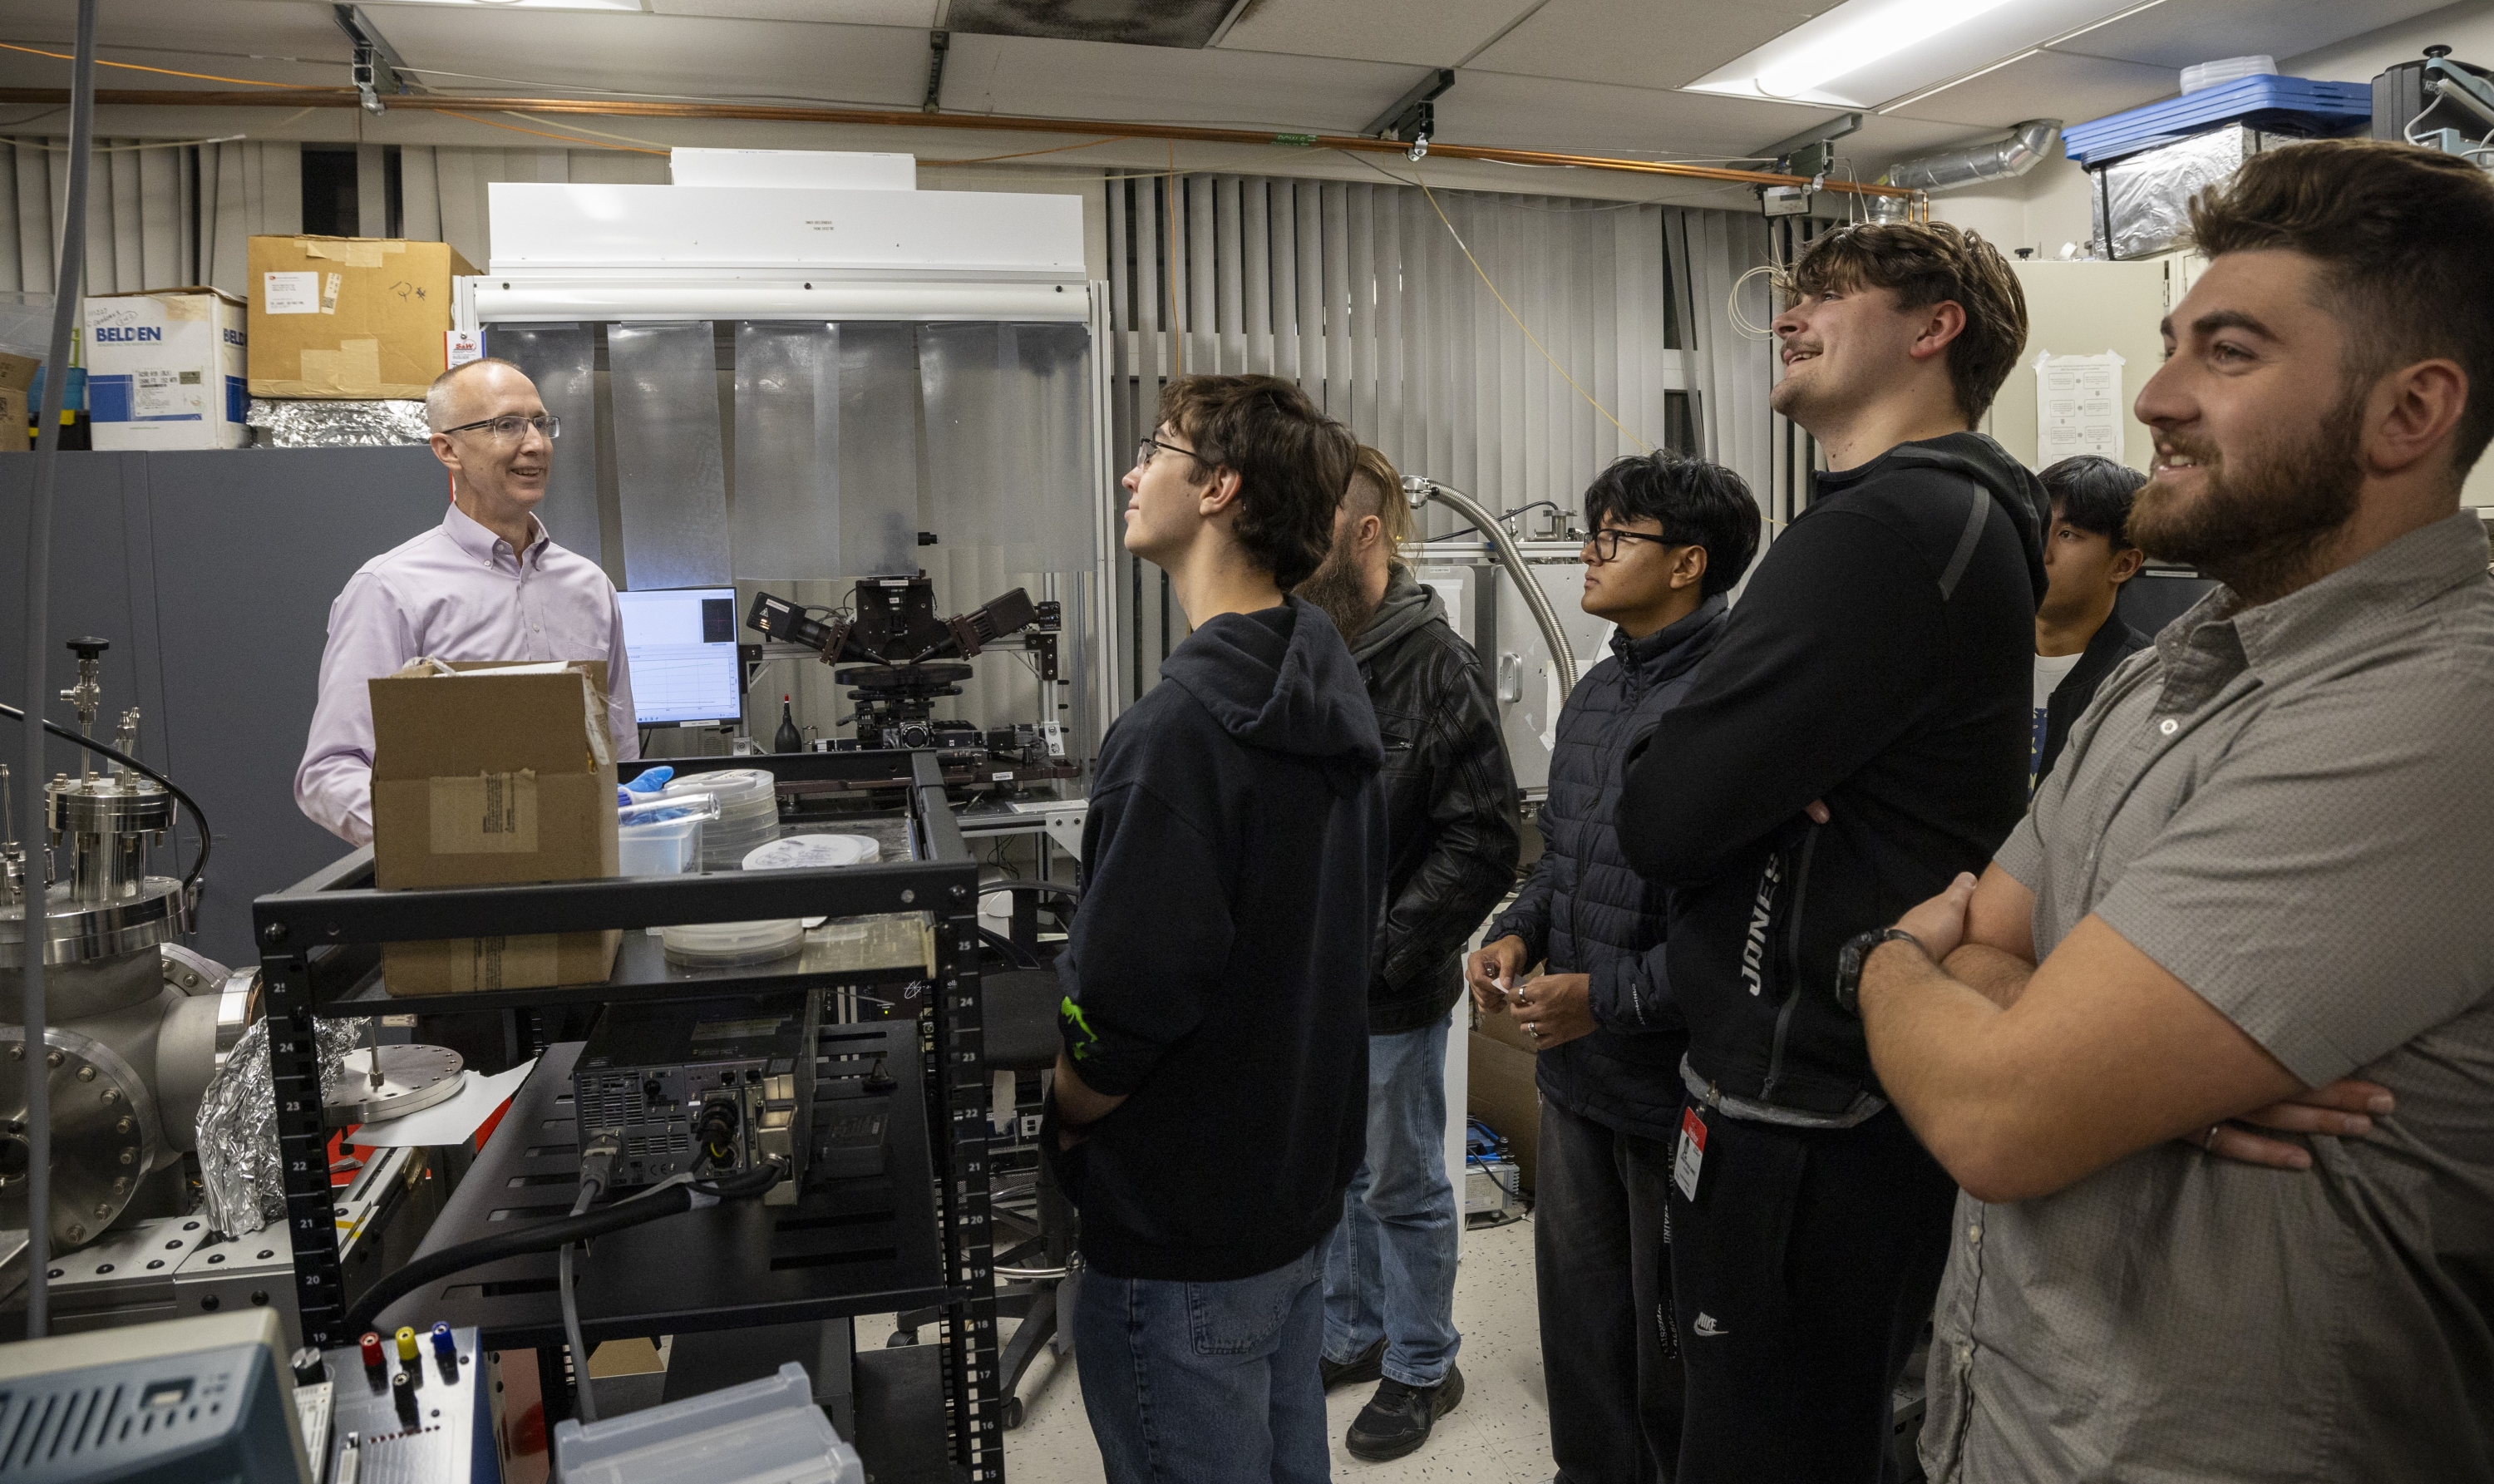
[1688,0,2140,107]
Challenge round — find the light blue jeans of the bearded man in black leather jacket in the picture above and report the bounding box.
[1324,1015,1464,1387]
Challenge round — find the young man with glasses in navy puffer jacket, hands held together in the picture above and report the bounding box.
[1466,454,1761,1484]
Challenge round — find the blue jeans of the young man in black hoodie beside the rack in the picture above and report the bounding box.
[1072,1247,1332,1484]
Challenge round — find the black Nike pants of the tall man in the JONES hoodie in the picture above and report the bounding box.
[1671,1107,1958,1484]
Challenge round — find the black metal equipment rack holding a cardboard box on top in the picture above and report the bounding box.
[252,751,1005,1484]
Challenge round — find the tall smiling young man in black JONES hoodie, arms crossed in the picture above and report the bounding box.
[1619,224,2048,1484]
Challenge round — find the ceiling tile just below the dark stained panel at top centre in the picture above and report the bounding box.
[943,35,1422,135]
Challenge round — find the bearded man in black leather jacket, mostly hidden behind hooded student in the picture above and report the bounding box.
[1299,449,1521,1462]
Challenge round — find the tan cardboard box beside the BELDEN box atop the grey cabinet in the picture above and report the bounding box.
[249,237,476,399]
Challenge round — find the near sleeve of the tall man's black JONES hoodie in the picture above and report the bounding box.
[1619,509,1948,885]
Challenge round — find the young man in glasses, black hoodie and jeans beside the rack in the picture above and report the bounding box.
[1047,377,1387,1484]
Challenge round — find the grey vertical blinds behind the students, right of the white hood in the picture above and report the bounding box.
[1105,175,1776,688]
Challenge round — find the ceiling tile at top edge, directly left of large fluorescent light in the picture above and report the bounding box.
[1471,0,1826,87]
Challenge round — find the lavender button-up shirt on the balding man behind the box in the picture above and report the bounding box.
[294,504,641,846]
